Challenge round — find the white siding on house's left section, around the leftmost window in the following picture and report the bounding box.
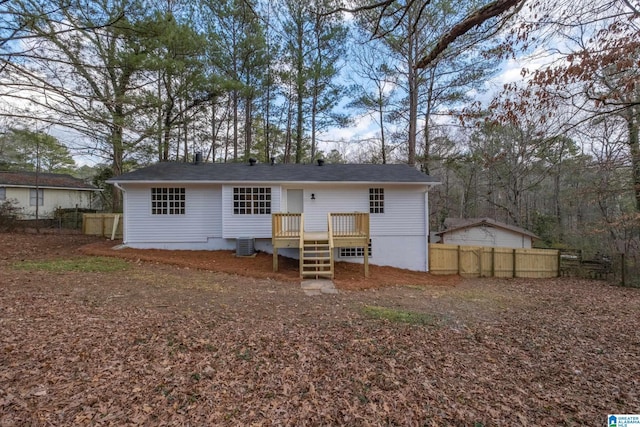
[125,185,222,244]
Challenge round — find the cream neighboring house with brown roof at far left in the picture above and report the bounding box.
[0,172,98,219]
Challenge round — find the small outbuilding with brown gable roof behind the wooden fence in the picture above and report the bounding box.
[436,218,538,249]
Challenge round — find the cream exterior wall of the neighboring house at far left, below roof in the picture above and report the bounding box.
[6,187,94,219]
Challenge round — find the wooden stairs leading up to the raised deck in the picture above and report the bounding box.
[300,233,333,279]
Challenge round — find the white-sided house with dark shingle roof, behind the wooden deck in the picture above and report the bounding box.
[107,162,437,273]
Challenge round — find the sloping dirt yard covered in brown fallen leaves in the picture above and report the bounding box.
[0,234,640,426]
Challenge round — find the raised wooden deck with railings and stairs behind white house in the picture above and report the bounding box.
[271,212,370,278]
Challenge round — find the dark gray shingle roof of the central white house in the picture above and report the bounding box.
[107,162,438,184]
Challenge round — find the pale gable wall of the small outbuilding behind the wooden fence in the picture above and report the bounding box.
[443,227,531,249]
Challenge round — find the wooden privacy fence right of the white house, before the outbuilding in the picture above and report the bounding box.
[429,243,560,278]
